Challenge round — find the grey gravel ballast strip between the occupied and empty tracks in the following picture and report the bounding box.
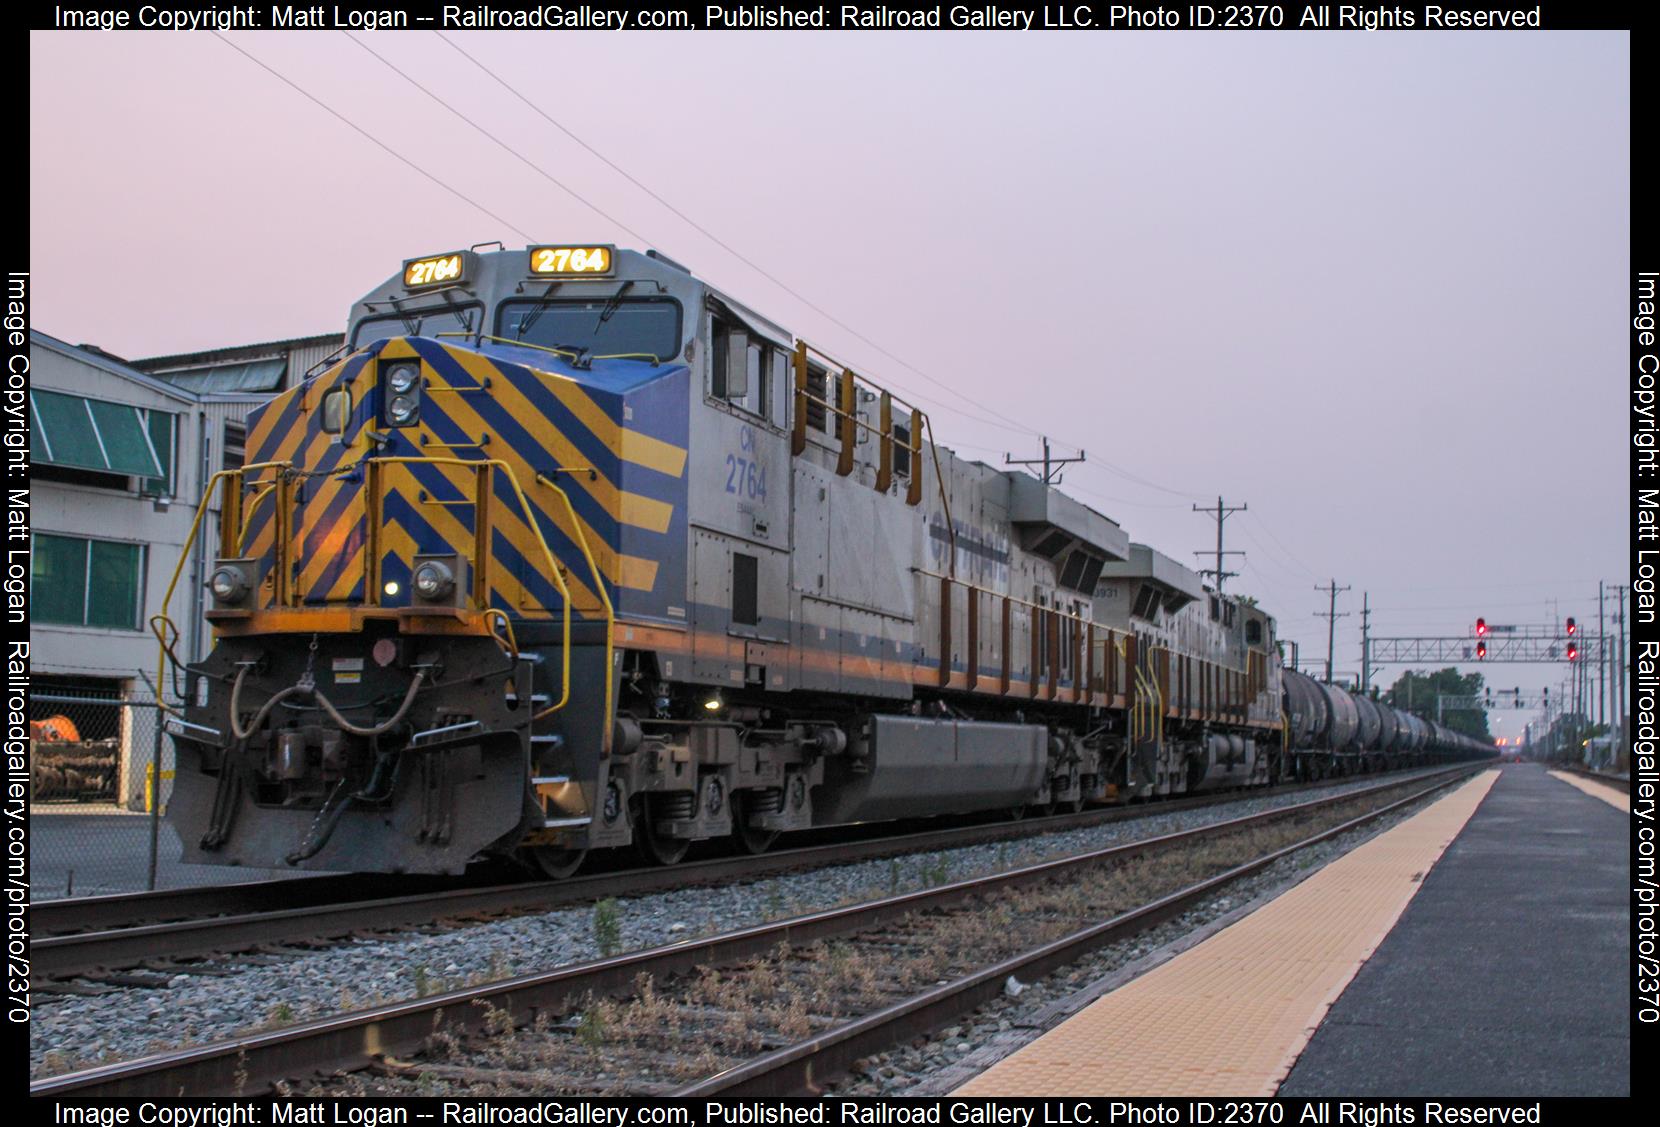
[30,773,1447,1090]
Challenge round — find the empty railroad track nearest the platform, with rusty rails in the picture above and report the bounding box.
[30,765,1484,1095]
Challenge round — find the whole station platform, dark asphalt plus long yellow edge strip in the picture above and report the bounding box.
[956,764,1630,1095]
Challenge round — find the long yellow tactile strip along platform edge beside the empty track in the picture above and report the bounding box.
[955,770,1497,1095]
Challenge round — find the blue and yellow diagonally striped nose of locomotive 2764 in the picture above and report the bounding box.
[237,337,686,617]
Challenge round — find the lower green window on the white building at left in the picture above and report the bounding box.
[28,533,144,631]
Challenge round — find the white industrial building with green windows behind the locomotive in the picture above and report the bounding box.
[30,330,342,807]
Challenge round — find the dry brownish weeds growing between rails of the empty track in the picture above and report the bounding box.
[302,780,1427,1095]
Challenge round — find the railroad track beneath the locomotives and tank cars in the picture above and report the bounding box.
[32,766,1454,986]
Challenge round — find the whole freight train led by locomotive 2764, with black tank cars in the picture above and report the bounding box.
[154,246,1482,875]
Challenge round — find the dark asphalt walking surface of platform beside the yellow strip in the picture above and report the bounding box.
[1280,764,1632,1095]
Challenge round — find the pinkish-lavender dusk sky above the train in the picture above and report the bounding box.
[30,32,1630,713]
